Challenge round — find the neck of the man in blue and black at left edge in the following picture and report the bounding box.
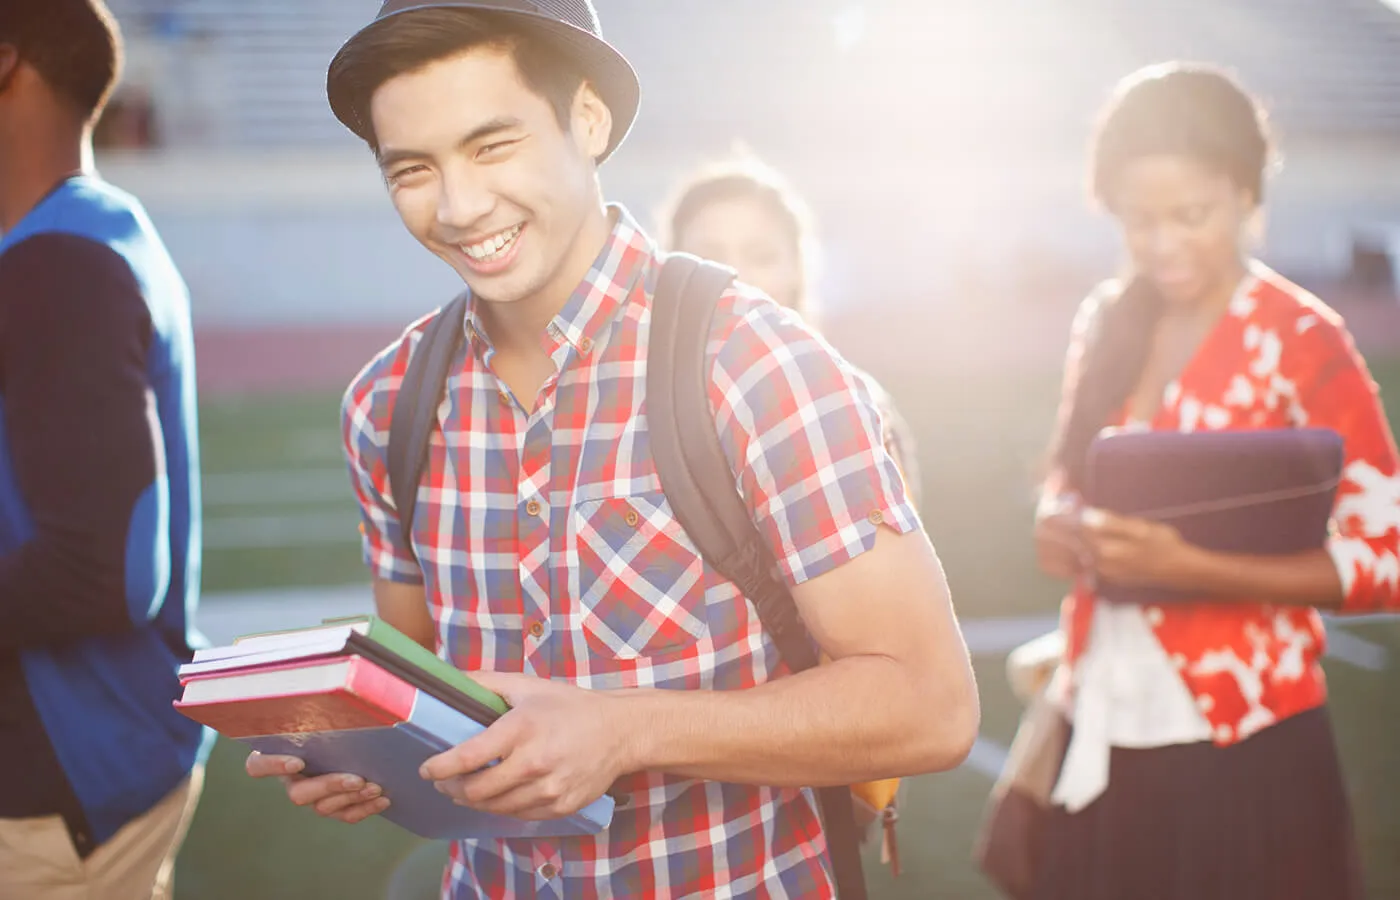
[0,123,94,232]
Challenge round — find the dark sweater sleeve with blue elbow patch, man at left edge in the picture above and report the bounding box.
[0,234,169,651]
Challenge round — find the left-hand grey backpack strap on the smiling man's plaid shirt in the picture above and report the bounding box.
[386,291,469,554]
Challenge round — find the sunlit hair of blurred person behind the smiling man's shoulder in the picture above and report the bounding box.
[661,155,811,312]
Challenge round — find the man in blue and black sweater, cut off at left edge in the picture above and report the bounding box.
[0,0,207,900]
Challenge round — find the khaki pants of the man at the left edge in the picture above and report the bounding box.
[0,766,204,900]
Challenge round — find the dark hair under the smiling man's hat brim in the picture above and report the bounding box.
[326,8,585,153]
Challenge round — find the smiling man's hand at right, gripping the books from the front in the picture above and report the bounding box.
[421,672,644,819]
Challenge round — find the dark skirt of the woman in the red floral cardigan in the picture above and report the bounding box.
[1033,708,1365,900]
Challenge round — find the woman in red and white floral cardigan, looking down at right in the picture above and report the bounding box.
[1035,66,1400,900]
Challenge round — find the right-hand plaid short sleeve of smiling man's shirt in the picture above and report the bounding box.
[711,294,920,585]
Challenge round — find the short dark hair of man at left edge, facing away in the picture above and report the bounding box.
[0,0,122,123]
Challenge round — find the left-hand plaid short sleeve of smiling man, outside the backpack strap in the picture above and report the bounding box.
[340,337,423,584]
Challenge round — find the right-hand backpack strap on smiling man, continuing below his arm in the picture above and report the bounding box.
[647,253,867,900]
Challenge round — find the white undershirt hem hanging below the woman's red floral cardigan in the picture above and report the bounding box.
[1050,602,1211,812]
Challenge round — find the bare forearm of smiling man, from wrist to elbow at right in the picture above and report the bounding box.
[616,646,979,787]
